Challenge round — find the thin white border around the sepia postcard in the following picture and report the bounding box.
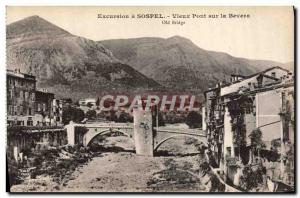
[0,0,300,197]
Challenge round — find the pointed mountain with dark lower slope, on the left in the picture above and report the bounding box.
[6,16,161,99]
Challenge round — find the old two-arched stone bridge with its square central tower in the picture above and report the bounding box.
[66,111,207,156]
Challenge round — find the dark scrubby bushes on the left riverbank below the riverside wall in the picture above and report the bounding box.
[8,146,94,190]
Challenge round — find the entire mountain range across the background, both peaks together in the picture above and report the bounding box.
[6,16,293,99]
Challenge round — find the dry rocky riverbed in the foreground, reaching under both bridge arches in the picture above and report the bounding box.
[11,136,209,192]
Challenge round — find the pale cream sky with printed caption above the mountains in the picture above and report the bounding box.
[6,6,294,63]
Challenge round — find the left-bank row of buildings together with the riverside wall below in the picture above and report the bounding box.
[6,70,66,162]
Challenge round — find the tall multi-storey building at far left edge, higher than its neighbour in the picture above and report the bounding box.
[6,70,36,125]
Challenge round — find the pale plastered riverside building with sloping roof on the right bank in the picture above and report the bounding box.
[203,67,294,184]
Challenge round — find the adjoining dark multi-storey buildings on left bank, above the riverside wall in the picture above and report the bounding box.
[6,70,61,126]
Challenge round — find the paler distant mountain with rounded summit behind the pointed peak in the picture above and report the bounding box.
[99,36,283,92]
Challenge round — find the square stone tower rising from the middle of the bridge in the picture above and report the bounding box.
[133,109,154,156]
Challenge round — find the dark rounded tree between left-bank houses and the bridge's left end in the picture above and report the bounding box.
[62,106,84,125]
